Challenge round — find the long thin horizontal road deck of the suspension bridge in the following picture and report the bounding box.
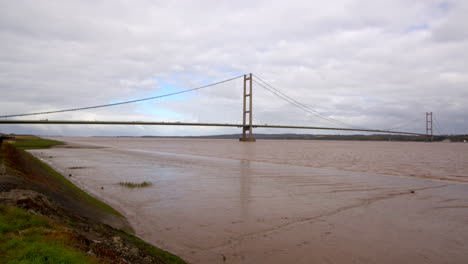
[0,119,426,136]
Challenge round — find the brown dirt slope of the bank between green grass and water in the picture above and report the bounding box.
[0,138,185,263]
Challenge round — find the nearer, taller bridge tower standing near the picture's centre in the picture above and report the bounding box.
[239,73,255,142]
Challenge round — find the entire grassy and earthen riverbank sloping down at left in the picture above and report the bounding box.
[0,136,185,263]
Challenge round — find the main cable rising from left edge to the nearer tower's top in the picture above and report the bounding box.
[0,75,244,118]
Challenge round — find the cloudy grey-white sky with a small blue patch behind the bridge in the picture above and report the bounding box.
[0,0,468,136]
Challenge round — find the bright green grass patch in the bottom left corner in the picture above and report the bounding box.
[0,206,98,264]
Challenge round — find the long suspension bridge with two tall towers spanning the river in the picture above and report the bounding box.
[0,73,432,142]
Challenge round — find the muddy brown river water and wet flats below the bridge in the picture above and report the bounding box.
[32,138,468,263]
